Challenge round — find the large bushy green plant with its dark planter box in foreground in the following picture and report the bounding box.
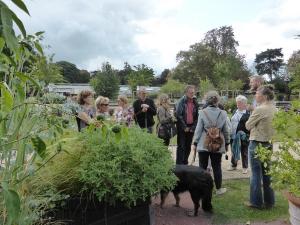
[30,122,176,225]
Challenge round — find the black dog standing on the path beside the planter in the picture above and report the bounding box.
[160,165,213,216]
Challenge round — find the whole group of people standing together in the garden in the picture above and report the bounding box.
[78,76,276,208]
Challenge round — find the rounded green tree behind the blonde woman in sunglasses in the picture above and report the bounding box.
[90,62,119,99]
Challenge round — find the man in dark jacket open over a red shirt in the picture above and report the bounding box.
[176,85,199,165]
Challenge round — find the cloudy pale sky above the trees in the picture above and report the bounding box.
[4,0,300,74]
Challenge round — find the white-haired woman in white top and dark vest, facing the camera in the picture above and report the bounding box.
[228,95,250,174]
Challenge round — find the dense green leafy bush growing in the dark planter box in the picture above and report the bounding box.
[78,125,176,206]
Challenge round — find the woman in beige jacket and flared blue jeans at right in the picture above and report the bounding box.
[246,85,276,209]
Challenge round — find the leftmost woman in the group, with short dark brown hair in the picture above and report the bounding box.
[76,90,96,131]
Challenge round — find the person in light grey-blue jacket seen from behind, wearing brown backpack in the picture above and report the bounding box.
[192,91,230,195]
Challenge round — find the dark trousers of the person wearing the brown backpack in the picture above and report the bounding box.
[199,152,222,189]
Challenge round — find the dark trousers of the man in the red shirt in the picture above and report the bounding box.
[176,129,194,165]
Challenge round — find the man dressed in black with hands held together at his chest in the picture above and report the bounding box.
[133,87,156,133]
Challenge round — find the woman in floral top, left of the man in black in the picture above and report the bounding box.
[115,95,133,127]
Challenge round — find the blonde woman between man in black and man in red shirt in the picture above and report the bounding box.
[157,94,173,146]
